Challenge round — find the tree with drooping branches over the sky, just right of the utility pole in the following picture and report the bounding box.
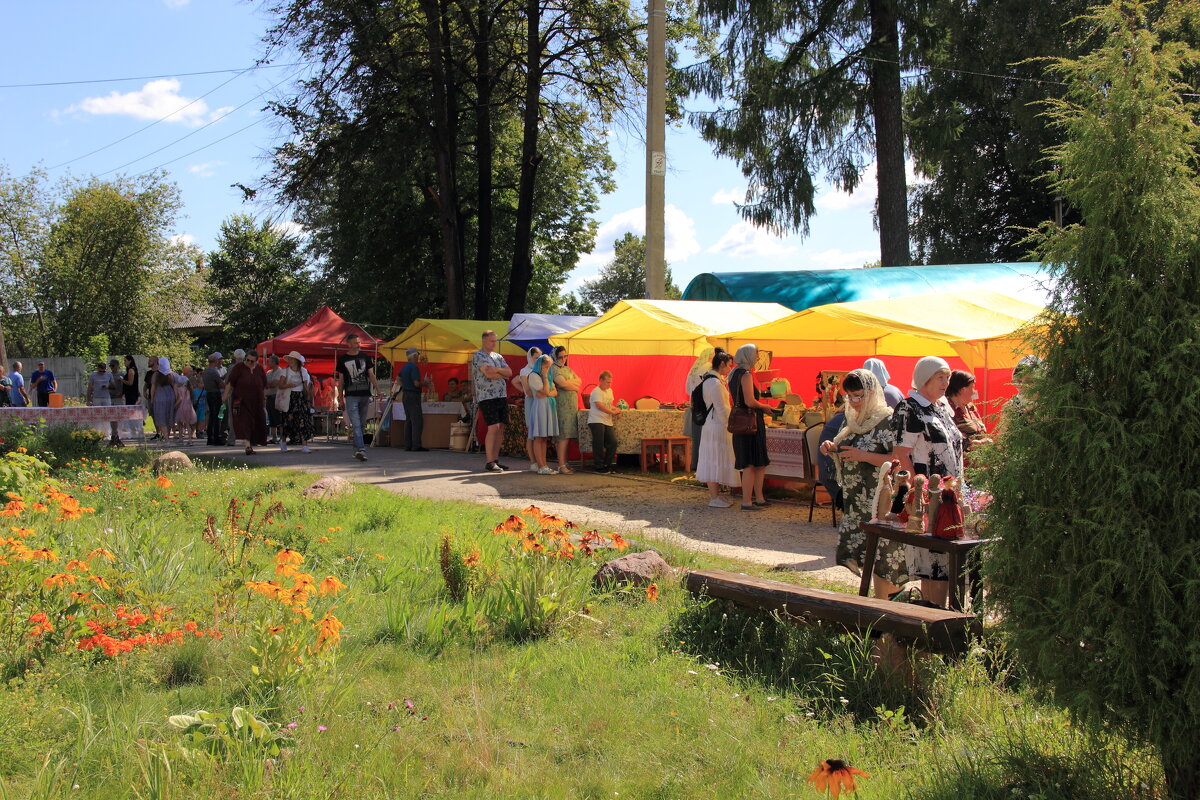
[683,0,925,266]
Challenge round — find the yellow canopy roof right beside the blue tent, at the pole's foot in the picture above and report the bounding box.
[550,300,792,357]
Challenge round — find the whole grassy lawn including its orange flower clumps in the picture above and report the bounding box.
[0,434,1158,800]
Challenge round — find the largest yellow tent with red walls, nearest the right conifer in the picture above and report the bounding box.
[709,289,1044,410]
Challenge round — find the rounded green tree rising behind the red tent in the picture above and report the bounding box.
[204,213,317,347]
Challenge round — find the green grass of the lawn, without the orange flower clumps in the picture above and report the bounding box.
[0,452,1158,800]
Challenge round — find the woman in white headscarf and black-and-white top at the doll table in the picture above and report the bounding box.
[892,355,962,606]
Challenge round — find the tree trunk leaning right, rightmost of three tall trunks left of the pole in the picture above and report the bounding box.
[504,0,541,319]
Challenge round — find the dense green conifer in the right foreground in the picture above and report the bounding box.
[984,0,1200,800]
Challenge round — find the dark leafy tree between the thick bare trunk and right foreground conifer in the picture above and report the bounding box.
[905,0,1090,264]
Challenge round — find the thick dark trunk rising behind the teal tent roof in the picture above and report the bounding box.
[866,0,910,266]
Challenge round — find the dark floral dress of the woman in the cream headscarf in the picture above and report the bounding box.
[836,417,911,585]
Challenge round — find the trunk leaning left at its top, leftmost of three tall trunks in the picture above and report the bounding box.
[420,0,466,319]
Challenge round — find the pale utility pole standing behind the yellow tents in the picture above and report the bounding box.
[646,0,667,300]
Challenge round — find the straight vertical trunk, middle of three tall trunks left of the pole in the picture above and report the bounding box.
[474,2,494,319]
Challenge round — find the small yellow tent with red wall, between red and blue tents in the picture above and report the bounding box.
[379,319,524,396]
